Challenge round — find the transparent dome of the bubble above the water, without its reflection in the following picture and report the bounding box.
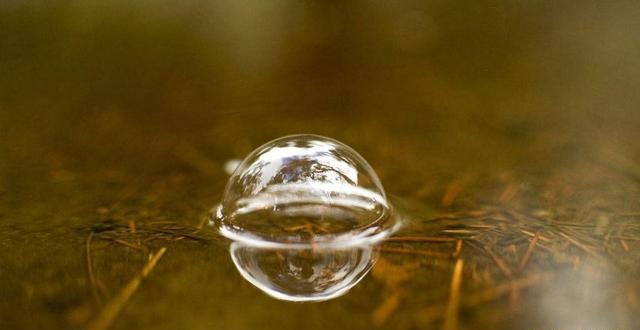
[214,135,396,247]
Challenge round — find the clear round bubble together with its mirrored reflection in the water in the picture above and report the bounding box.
[212,135,400,302]
